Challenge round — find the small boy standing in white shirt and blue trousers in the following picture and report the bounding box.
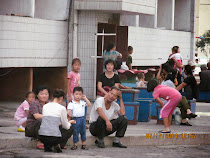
[67,87,91,150]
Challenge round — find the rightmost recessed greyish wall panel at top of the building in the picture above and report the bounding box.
[174,0,191,31]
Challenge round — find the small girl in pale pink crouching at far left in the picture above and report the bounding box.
[14,92,35,132]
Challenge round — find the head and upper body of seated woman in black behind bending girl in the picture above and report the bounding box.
[176,65,198,100]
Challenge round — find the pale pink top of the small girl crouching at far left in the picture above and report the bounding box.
[14,100,30,121]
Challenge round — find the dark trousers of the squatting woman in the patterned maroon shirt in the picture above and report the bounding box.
[25,119,42,139]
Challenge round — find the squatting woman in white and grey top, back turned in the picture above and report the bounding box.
[39,89,75,153]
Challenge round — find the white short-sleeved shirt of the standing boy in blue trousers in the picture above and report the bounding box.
[67,100,87,117]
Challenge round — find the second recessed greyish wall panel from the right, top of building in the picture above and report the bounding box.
[157,0,174,30]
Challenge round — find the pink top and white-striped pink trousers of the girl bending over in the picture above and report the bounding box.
[152,85,182,118]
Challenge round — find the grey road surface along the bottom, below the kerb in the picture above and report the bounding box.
[0,145,210,158]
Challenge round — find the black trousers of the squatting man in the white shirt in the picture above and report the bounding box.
[89,116,128,139]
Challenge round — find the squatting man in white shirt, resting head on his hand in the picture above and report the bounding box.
[89,87,128,148]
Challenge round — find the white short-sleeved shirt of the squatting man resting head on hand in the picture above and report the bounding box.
[90,97,120,123]
